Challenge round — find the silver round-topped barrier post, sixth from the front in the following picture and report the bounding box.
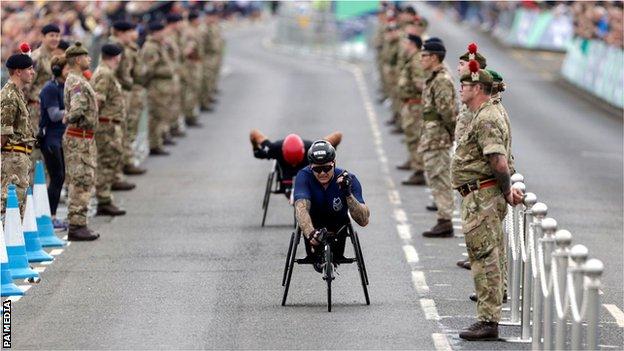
[520,193,537,341]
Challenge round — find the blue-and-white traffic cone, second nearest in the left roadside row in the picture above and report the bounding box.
[4,184,39,279]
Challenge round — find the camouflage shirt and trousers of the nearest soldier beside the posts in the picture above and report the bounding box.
[452,100,511,322]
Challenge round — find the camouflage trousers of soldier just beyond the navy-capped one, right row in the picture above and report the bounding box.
[401,103,425,172]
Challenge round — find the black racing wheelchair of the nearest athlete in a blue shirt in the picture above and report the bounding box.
[282,222,370,312]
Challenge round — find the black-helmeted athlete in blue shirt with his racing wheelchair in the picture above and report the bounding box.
[282,140,370,312]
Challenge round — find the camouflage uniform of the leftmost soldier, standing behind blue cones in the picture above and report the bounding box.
[0,80,35,213]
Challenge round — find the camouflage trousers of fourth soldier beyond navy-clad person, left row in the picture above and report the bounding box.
[147,79,172,149]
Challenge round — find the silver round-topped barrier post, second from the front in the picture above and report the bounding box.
[568,245,589,350]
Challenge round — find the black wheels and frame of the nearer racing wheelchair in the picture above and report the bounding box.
[282,222,370,312]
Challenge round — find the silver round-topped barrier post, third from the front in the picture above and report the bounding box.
[552,230,572,350]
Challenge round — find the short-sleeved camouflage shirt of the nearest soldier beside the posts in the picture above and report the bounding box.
[451,100,511,188]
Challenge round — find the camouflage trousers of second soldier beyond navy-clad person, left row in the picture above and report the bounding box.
[95,122,124,205]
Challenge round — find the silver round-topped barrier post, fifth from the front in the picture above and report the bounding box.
[529,202,548,350]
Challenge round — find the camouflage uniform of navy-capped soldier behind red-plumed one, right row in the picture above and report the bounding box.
[418,66,457,220]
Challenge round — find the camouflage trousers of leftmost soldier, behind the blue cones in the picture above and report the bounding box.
[1,151,32,214]
